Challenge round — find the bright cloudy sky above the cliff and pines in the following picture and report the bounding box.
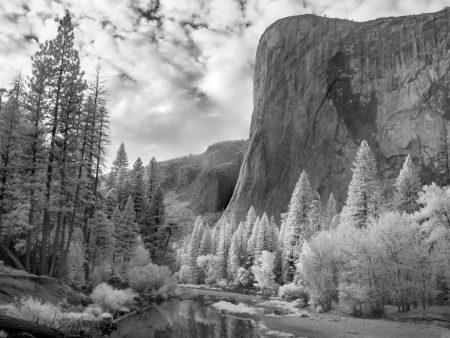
[0,0,450,163]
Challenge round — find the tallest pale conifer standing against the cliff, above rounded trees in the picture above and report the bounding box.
[341,141,379,228]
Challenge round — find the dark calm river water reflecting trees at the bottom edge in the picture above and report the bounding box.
[112,299,260,338]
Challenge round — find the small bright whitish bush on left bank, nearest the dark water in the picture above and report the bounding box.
[91,283,137,312]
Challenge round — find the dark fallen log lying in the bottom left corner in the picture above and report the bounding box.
[0,314,65,338]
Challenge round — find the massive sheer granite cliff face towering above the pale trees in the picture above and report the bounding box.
[224,9,450,220]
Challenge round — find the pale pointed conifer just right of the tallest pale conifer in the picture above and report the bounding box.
[394,155,422,214]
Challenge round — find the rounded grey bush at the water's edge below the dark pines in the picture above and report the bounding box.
[127,263,177,298]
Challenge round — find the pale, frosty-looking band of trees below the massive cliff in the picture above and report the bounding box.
[179,139,450,314]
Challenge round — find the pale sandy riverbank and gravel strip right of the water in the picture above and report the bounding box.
[179,287,450,338]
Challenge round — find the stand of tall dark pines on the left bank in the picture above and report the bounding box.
[0,13,171,285]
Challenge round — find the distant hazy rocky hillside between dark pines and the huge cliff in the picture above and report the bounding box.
[158,141,247,214]
